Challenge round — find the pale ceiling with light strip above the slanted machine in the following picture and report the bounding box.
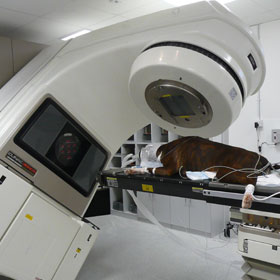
[0,0,280,44]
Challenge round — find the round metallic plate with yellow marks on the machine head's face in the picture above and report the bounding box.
[145,80,213,128]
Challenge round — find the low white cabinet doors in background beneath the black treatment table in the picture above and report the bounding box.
[137,192,225,236]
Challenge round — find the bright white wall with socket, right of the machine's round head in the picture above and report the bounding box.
[229,21,280,162]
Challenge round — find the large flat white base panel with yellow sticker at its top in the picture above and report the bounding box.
[0,194,80,280]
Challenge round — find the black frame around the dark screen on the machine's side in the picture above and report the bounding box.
[14,97,108,197]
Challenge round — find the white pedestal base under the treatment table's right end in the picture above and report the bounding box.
[238,209,280,280]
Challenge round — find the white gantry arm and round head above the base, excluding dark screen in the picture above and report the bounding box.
[0,1,265,215]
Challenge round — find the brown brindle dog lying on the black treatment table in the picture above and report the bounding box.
[127,136,271,185]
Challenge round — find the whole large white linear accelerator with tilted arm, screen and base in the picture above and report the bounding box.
[0,1,265,280]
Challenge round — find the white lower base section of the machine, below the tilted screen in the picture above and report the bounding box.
[0,165,98,280]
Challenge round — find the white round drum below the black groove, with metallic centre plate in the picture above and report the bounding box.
[129,43,243,137]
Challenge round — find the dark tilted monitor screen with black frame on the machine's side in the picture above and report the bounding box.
[15,98,108,196]
